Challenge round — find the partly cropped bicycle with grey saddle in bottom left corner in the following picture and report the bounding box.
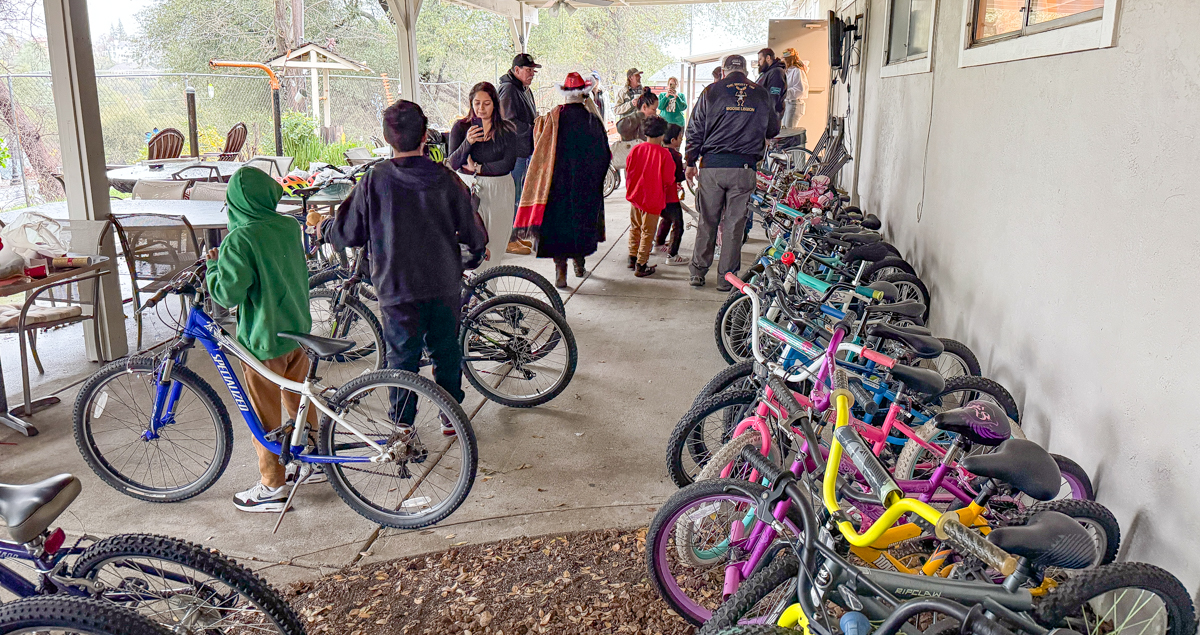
[0,474,305,635]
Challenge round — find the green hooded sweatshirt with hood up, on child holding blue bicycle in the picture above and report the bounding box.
[208,167,312,360]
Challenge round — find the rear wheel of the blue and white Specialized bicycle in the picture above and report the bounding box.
[317,370,479,529]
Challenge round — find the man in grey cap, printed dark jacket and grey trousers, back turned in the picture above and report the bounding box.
[686,55,779,290]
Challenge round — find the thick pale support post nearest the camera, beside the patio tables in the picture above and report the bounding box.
[43,0,128,360]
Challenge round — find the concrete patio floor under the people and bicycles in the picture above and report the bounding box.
[0,190,762,583]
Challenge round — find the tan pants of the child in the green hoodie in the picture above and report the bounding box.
[241,348,317,487]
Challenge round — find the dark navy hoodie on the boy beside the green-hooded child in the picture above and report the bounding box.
[322,156,487,306]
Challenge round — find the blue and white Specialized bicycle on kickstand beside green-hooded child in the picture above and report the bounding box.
[74,256,478,529]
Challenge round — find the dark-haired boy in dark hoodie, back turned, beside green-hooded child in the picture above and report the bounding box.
[320,100,487,424]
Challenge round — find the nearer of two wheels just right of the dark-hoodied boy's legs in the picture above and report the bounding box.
[458,295,580,408]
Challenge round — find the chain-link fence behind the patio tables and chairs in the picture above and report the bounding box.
[0,71,469,210]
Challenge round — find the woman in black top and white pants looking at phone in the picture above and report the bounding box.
[448,82,517,271]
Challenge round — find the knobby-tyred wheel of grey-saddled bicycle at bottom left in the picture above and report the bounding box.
[73,534,304,635]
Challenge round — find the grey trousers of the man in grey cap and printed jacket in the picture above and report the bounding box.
[689,168,755,279]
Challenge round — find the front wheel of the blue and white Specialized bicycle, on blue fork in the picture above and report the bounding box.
[73,357,233,503]
